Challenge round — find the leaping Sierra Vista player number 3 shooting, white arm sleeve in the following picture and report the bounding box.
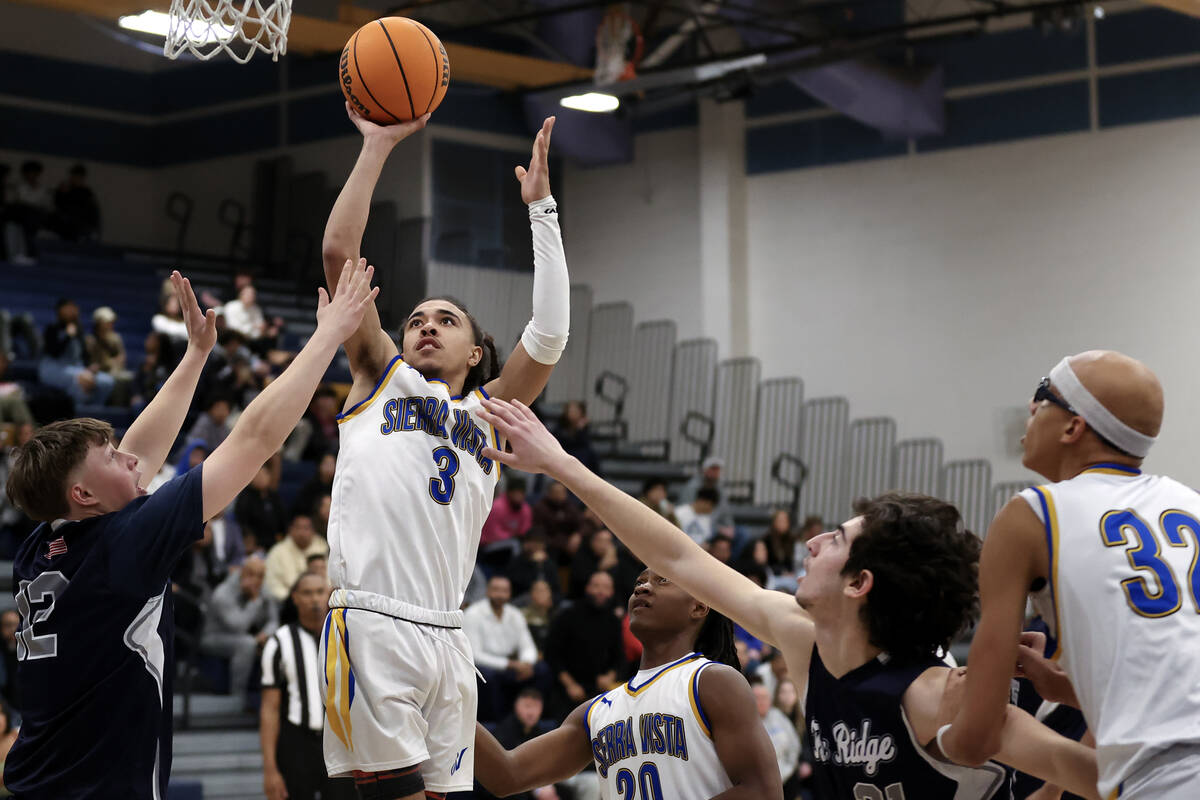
[322,106,570,800]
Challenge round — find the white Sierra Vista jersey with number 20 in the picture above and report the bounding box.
[587,652,732,800]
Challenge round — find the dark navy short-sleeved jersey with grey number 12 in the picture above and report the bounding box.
[4,467,204,800]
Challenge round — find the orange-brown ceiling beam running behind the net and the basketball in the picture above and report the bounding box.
[3,0,592,90]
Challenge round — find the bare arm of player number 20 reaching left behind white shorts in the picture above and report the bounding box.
[475,703,595,798]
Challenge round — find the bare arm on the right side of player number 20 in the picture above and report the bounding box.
[700,664,784,800]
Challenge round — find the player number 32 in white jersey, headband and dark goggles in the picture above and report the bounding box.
[940,350,1200,800]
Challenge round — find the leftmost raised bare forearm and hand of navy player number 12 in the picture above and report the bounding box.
[121,270,217,488]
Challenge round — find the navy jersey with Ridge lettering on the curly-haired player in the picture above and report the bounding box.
[804,646,1010,800]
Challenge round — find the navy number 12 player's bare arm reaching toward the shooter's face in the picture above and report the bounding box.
[203,264,379,521]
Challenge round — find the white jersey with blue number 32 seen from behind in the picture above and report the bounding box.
[1021,464,1200,796]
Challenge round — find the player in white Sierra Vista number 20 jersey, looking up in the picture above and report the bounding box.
[475,570,784,800]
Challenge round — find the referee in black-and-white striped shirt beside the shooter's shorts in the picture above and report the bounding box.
[259,572,356,800]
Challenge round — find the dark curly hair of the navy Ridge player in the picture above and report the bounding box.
[842,492,982,660]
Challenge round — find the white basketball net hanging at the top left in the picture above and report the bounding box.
[163,0,292,64]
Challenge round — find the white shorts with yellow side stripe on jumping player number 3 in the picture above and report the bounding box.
[320,608,478,792]
